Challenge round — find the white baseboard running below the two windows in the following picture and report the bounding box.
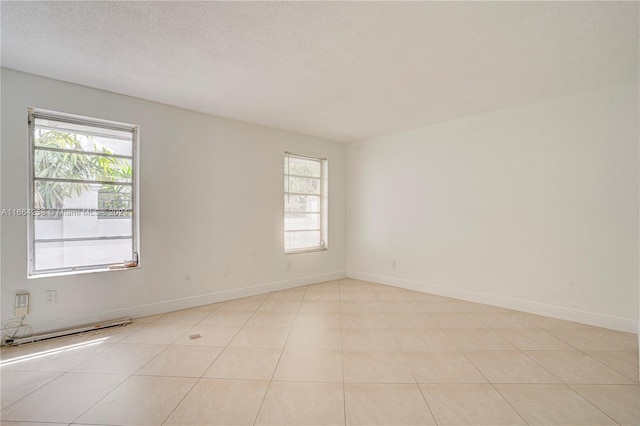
[2,271,347,337]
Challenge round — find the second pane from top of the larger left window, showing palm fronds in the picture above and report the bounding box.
[34,148,133,182]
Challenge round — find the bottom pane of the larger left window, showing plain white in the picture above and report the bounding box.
[35,239,133,270]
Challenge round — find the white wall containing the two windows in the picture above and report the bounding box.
[1,69,346,331]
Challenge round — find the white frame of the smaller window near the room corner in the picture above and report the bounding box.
[283,151,329,254]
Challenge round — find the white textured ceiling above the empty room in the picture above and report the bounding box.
[0,1,639,142]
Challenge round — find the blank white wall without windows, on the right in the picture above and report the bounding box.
[347,85,639,332]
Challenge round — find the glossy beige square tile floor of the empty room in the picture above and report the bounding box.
[0,279,640,426]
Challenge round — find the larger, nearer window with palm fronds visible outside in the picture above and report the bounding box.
[28,108,138,277]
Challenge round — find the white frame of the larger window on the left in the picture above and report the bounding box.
[27,107,140,278]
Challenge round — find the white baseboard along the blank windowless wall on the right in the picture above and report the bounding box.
[347,271,640,334]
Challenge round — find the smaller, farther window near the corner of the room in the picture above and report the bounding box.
[284,152,327,253]
